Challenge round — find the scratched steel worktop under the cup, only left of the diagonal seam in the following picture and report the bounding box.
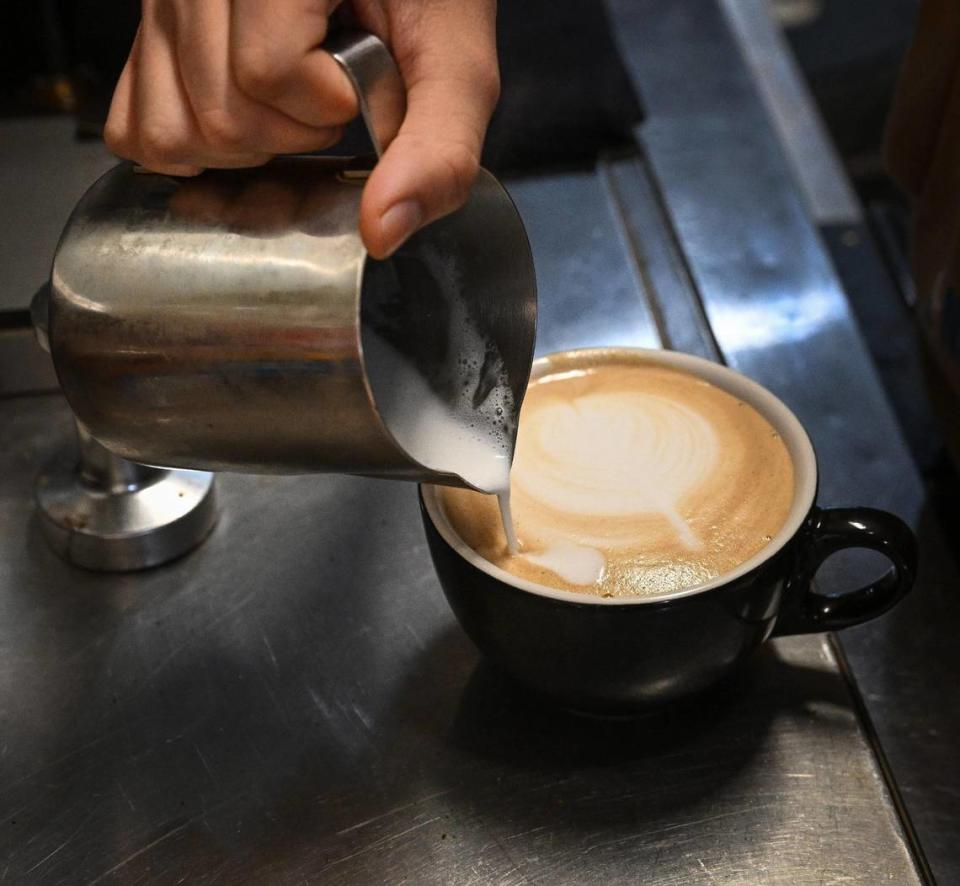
[0,161,918,886]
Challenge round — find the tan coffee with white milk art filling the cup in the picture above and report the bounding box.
[441,356,794,597]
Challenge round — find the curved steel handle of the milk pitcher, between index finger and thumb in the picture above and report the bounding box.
[324,32,407,157]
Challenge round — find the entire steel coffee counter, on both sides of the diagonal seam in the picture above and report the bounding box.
[0,0,960,886]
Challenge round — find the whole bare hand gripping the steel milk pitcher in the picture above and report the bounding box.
[105,0,499,258]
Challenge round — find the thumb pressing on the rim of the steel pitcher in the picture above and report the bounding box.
[360,35,500,258]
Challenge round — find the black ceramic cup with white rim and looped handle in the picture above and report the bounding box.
[420,348,917,714]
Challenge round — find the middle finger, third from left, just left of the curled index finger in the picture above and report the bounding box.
[176,0,342,155]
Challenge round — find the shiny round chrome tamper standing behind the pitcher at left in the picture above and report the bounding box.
[31,288,217,572]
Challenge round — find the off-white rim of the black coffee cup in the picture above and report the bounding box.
[420,347,817,606]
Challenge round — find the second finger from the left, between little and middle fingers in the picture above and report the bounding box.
[134,2,270,175]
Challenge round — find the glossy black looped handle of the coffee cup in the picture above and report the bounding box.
[773,508,917,637]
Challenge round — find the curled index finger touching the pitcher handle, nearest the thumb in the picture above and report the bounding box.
[230,0,358,127]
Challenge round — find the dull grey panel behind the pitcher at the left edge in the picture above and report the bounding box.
[0,117,116,314]
